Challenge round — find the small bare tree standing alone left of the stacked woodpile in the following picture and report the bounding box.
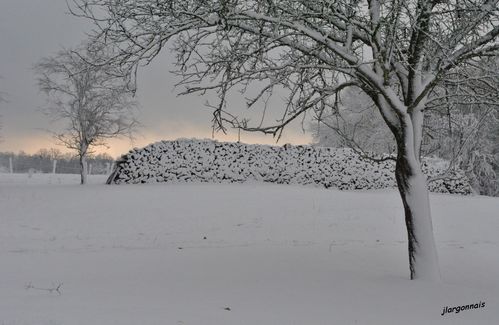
[35,47,137,184]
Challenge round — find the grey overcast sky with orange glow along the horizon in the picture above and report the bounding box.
[0,0,310,156]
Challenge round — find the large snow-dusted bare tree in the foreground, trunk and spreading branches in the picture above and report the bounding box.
[71,0,499,280]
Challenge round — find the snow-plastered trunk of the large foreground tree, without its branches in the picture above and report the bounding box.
[395,126,440,281]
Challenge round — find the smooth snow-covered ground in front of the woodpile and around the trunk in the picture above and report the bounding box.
[0,174,499,325]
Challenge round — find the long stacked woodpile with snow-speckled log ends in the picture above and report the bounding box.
[108,139,471,194]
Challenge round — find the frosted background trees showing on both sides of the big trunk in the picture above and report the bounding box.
[310,61,499,196]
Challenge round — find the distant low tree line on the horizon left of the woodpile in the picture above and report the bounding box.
[0,148,114,174]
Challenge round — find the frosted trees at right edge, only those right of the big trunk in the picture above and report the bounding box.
[423,57,499,195]
